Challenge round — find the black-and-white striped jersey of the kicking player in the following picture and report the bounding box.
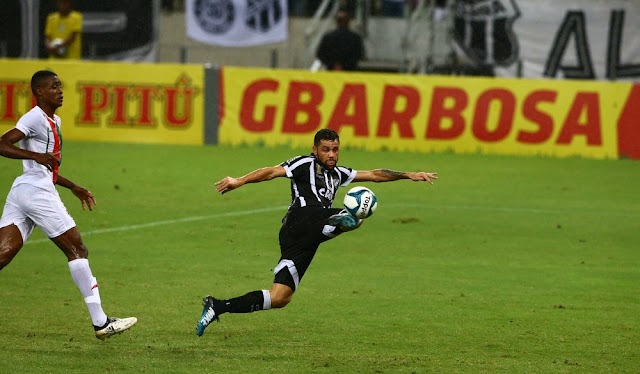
[280,154,356,209]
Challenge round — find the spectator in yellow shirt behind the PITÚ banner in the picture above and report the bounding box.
[44,0,82,59]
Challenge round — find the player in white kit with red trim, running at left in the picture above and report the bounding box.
[0,70,138,339]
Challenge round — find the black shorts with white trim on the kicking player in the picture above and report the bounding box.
[273,207,341,291]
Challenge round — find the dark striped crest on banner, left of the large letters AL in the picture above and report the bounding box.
[455,0,520,66]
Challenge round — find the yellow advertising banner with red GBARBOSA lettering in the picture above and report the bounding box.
[219,67,632,158]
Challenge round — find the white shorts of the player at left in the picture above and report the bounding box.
[0,184,76,243]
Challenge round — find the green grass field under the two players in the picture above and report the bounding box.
[0,142,640,373]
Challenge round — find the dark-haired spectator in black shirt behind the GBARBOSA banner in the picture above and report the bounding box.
[316,8,364,71]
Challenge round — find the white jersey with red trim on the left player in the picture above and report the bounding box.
[13,106,62,190]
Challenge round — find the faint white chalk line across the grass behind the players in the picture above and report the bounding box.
[25,204,640,245]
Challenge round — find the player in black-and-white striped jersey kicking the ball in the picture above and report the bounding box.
[196,129,438,336]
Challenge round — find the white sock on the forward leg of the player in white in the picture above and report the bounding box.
[69,258,107,326]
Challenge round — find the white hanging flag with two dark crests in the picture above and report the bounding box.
[185,0,288,47]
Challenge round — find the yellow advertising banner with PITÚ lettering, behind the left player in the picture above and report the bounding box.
[0,59,204,144]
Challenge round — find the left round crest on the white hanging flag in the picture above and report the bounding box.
[193,0,236,34]
